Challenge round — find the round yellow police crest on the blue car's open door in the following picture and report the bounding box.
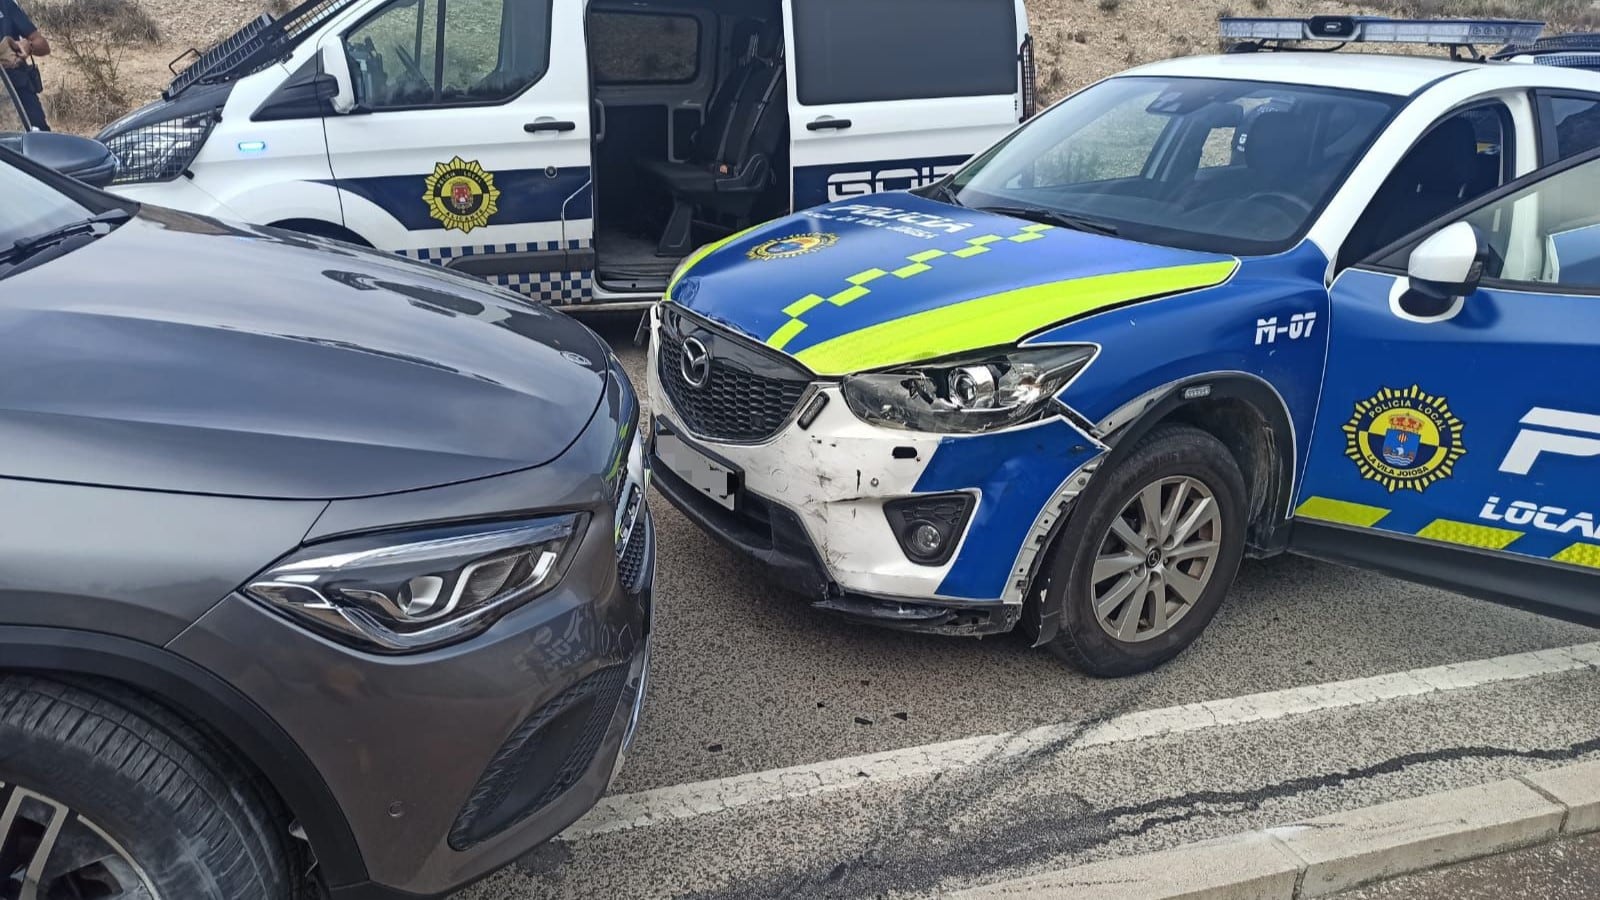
[1344,384,1467,493]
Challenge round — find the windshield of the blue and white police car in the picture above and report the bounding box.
[944,77,1402,255]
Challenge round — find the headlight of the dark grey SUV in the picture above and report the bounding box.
[243,514,587,653]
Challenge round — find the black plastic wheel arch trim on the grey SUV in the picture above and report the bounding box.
[0,626,366,887]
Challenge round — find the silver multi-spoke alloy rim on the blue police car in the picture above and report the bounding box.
[1090,476,1222,644]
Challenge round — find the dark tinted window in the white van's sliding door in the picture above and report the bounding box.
[794,0,1021,106]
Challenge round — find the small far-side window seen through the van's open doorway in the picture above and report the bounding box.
[589,11,699,85]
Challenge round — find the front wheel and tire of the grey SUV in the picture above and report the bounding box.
[0,674,298,900]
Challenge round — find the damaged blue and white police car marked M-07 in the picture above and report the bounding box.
[650,19,1600,676]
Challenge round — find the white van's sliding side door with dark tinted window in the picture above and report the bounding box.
[784,0,1027,210]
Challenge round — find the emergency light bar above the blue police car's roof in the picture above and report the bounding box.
[1219,16,1544,46]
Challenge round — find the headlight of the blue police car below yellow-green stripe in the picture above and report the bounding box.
[842,344,1099,434]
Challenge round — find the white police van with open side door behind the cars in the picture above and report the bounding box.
[101,0,1035,304]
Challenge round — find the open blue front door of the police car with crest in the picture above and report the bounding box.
[1293,152,1600,615]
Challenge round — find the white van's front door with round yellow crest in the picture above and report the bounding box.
[325,0,592,301]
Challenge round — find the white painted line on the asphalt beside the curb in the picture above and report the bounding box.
[562,642,1600,841]
